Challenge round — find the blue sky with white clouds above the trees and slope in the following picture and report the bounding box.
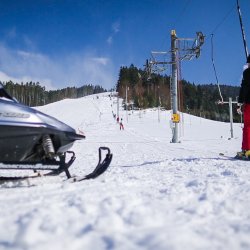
[0,0,250,89]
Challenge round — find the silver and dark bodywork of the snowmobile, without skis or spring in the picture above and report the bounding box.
[0,89,85,162]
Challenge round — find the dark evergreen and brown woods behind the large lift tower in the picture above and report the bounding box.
[116,65,240,121]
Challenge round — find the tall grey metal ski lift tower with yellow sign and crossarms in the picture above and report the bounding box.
[146,30,205,143]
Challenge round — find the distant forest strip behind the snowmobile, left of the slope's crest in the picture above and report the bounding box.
[2,81,106,106]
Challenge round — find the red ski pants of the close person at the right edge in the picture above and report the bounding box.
[242,103,250,150]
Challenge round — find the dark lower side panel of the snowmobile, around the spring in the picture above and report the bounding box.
[0,126,80,162]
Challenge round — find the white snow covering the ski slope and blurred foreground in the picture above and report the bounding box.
[0,93,250,250]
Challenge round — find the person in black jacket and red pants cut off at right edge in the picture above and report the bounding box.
[236,55,250,159]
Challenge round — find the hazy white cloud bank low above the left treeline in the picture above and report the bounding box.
[0,44,116,89]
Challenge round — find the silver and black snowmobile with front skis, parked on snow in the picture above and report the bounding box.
[0,84,112,181]
